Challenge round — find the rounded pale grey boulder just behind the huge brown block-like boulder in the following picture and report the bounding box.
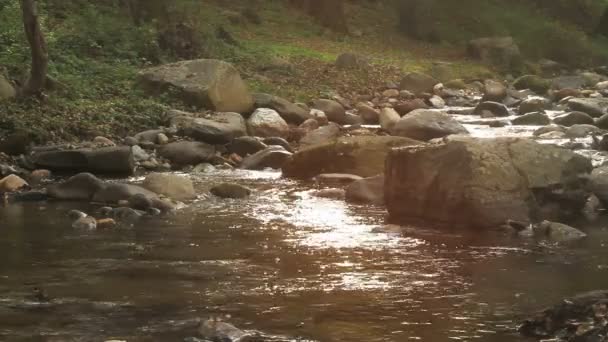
[390,109,468,141]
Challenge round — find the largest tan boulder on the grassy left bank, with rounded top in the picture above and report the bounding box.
[139,59,253,113]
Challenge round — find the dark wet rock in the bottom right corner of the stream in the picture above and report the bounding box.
[519,291,608,342]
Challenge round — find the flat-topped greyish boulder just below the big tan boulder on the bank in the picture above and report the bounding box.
[168,110,247,144]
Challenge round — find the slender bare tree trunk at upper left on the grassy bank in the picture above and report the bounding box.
[21,0,49,95]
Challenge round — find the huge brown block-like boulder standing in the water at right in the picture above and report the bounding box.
[385,137,591,228]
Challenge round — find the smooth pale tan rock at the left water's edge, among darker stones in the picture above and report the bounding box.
[142,173,196,201]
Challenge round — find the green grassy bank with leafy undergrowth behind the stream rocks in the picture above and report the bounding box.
[0,0,608,140]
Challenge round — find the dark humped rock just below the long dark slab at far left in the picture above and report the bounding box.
[47,173,106,201]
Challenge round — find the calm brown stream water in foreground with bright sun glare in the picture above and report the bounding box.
[0,171,608,342]
